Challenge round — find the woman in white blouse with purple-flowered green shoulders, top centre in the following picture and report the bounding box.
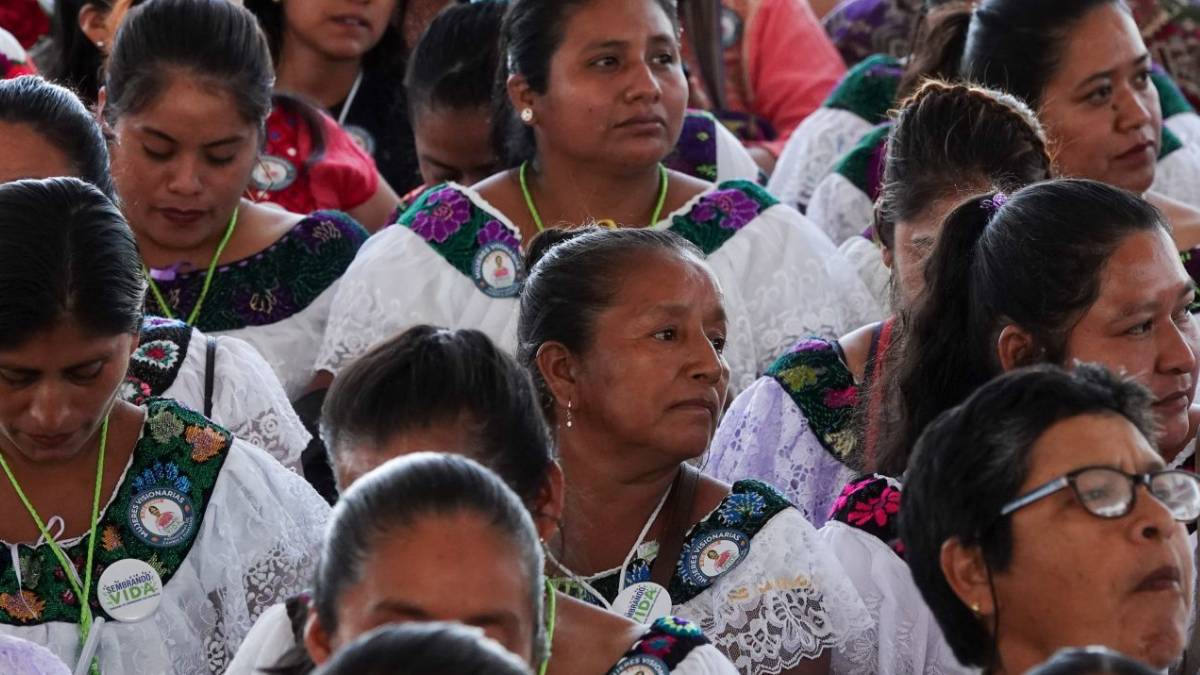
[318,0,878,389]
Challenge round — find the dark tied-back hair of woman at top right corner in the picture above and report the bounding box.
[901,0,1129,109]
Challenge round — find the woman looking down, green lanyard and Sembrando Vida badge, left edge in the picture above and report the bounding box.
[0,178,329,674]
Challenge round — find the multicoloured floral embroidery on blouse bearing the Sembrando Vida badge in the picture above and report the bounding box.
[0,399,233,625]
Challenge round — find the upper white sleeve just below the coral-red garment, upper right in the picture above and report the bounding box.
[767,108,872,210]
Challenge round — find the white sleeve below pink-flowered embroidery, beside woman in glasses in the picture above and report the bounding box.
[820,521,978,675]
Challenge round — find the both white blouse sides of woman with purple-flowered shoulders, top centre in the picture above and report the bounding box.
[316,186,882,392]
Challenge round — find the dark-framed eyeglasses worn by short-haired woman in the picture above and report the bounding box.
[1000,466,1200,522]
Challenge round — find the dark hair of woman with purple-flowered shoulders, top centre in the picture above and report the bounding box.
[492,0,679,168]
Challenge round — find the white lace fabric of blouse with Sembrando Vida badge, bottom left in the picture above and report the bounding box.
[0,432,329,675]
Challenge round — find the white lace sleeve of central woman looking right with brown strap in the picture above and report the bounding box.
[672,508,871,675]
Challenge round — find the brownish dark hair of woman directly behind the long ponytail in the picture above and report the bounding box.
[875,80,1051,247]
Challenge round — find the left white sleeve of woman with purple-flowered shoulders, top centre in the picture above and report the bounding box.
[317,226,517,374]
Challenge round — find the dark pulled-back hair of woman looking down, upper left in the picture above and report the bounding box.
[104,0,275,126]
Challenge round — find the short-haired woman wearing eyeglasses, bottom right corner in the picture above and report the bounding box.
[900,365,1200,674]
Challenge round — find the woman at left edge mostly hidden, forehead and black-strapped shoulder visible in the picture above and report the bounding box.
[0,77,310,468]
